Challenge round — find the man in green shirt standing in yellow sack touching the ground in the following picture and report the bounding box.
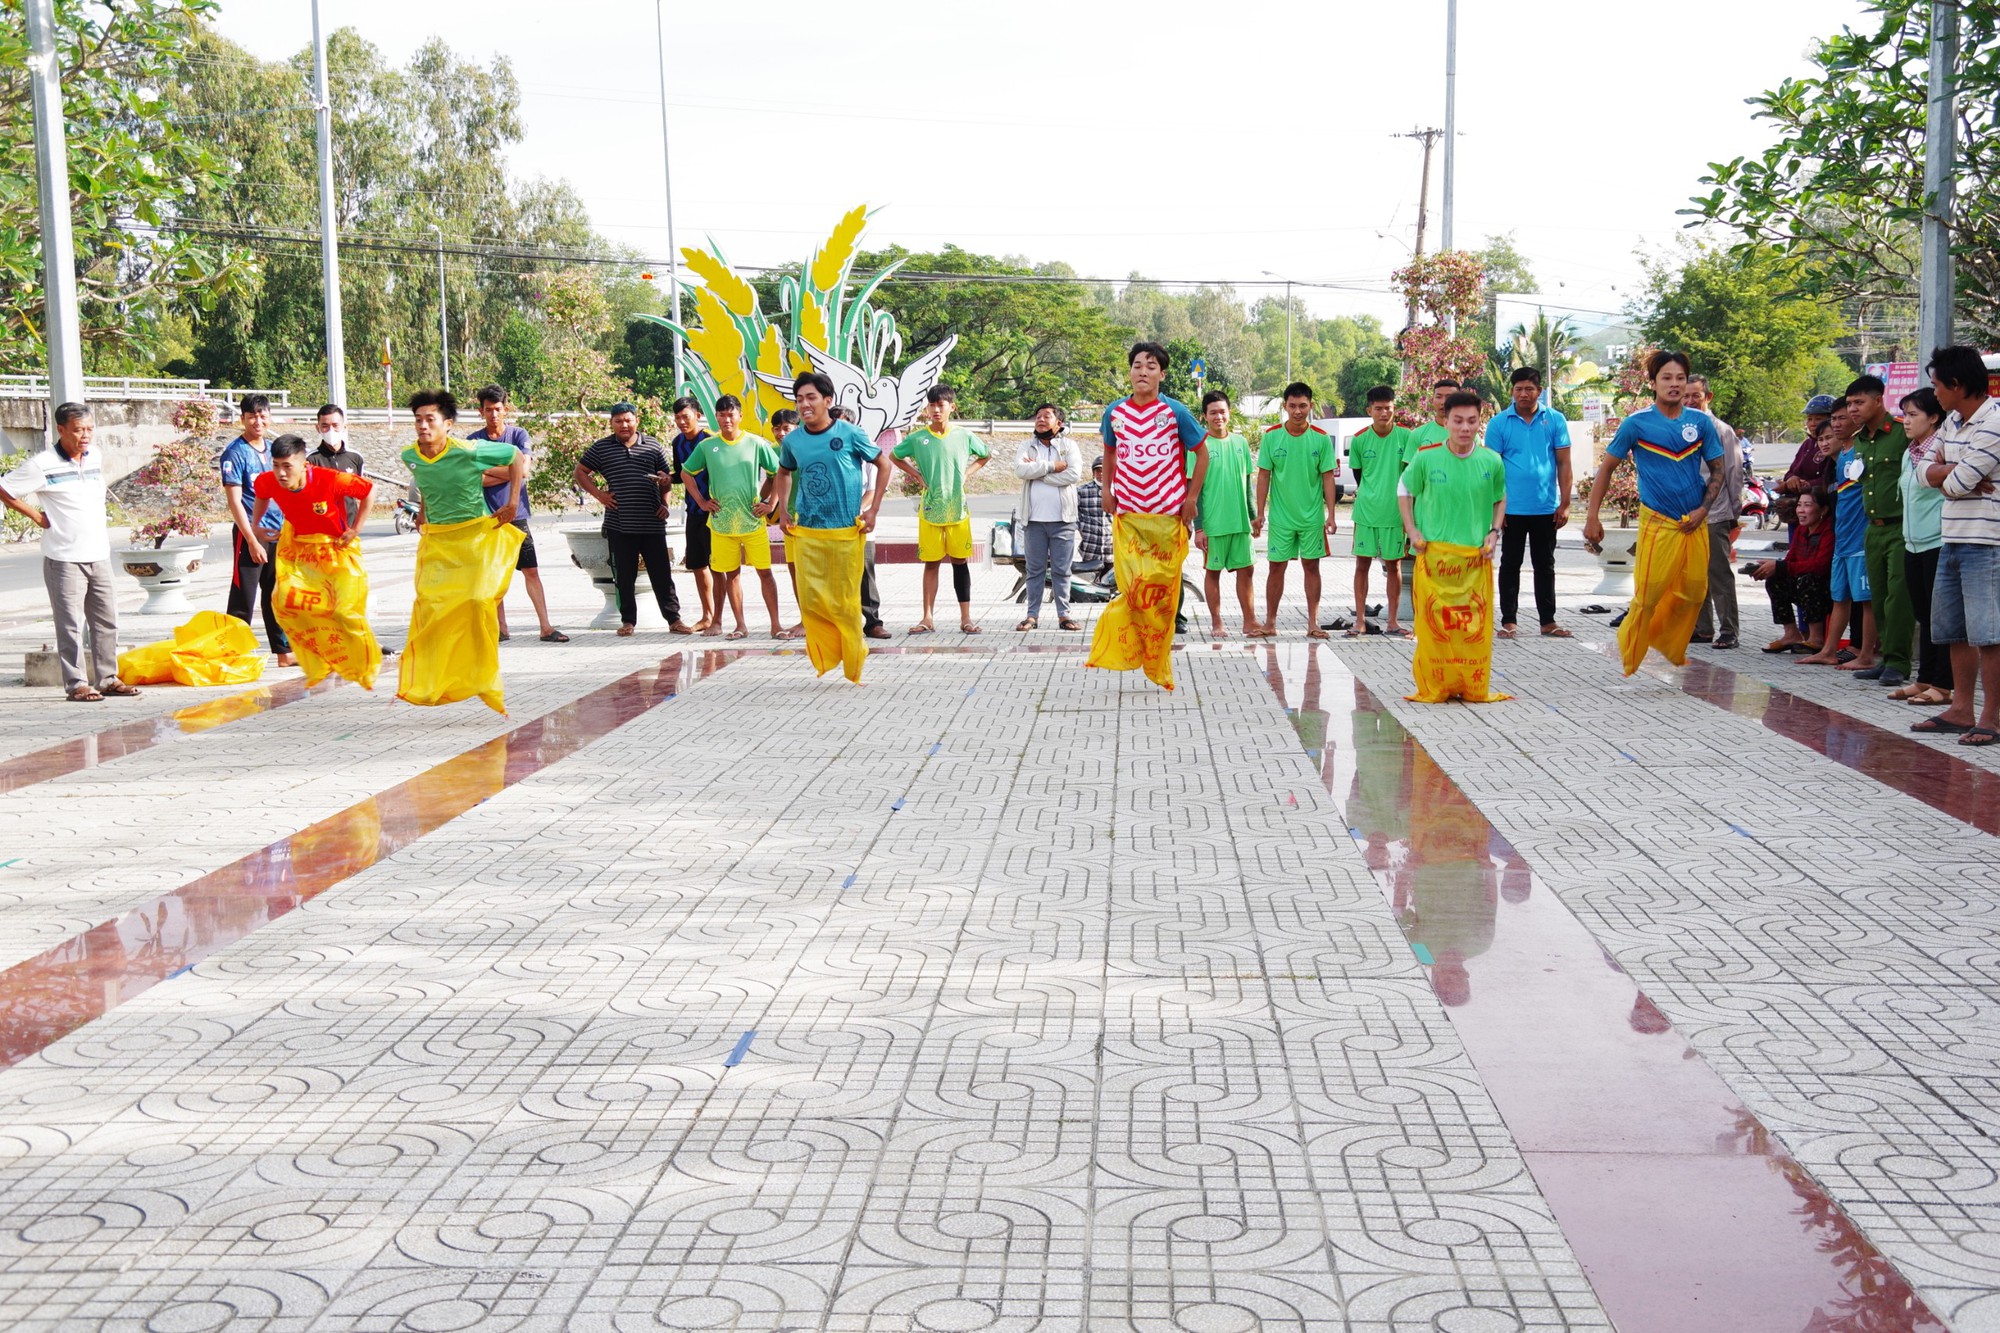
[1396,390,1510,703]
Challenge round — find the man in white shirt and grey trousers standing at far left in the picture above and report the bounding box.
[0,402,138,703]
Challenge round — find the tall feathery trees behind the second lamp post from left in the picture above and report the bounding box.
[168,28,610,406]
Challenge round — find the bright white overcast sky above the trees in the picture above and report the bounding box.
[220,0,1866,324]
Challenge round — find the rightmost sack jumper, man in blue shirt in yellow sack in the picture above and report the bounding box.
[1584,352,1726,677]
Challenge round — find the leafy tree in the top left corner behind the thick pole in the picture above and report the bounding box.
[0,0,250,372]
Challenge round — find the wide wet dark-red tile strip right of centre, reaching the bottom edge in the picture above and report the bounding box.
[1250,644,1944,1333]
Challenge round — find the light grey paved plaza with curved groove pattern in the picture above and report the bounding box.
[0,524,2000,1333]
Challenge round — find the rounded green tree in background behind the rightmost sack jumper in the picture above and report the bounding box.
[1636,244,1842,430]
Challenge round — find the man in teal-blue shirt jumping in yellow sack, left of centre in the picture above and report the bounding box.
[778,370,888,685]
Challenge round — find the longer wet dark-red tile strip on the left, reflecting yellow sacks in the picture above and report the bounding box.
[0,650,740,1069]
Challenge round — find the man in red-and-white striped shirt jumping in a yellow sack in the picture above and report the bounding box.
[1084,342,1208,691]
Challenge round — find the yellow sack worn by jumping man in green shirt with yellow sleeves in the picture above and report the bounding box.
[396,514,528,713]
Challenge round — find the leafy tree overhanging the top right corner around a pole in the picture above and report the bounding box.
[1682,0,2000,338]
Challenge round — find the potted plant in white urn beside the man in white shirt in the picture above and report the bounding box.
[118,398,224,616]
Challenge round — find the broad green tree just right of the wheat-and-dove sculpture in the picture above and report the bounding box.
[854,246,1130,420]
